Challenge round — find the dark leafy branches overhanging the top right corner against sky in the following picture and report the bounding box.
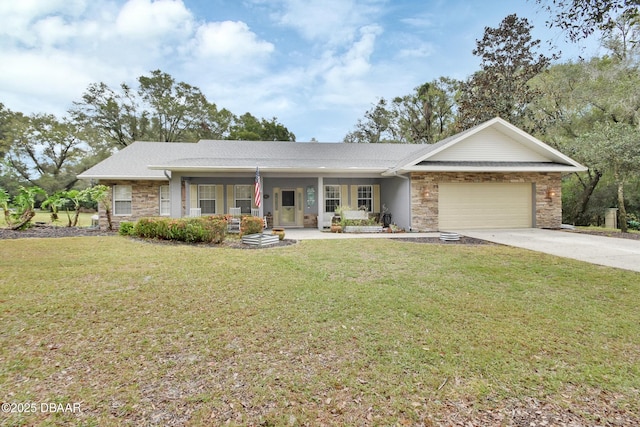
[536,0,640,42]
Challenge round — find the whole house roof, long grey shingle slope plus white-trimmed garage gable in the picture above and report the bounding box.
[78,118,586,179]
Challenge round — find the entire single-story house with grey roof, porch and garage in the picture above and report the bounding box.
[79,118,586,231]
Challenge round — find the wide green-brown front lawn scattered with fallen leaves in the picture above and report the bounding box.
[0,236,640,426]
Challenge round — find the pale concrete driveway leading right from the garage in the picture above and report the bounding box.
[457,228,640,272]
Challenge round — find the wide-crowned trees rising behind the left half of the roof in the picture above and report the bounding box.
[69,70,295,149]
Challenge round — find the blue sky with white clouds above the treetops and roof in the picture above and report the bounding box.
[0,0,597,142]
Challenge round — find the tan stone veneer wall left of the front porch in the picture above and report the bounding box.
[98,181,169,229]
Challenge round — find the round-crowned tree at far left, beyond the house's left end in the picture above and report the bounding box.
[6,114,88,192]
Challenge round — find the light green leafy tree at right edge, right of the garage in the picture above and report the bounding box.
[531,17,640,225]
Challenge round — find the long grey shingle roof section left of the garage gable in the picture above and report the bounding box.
[79,140,419,179]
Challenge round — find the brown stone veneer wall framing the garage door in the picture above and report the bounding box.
[411,172,562,231]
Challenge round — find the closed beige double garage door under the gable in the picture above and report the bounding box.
[438,182,533,231]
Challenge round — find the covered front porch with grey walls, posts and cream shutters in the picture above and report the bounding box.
[170,171,410,230]
